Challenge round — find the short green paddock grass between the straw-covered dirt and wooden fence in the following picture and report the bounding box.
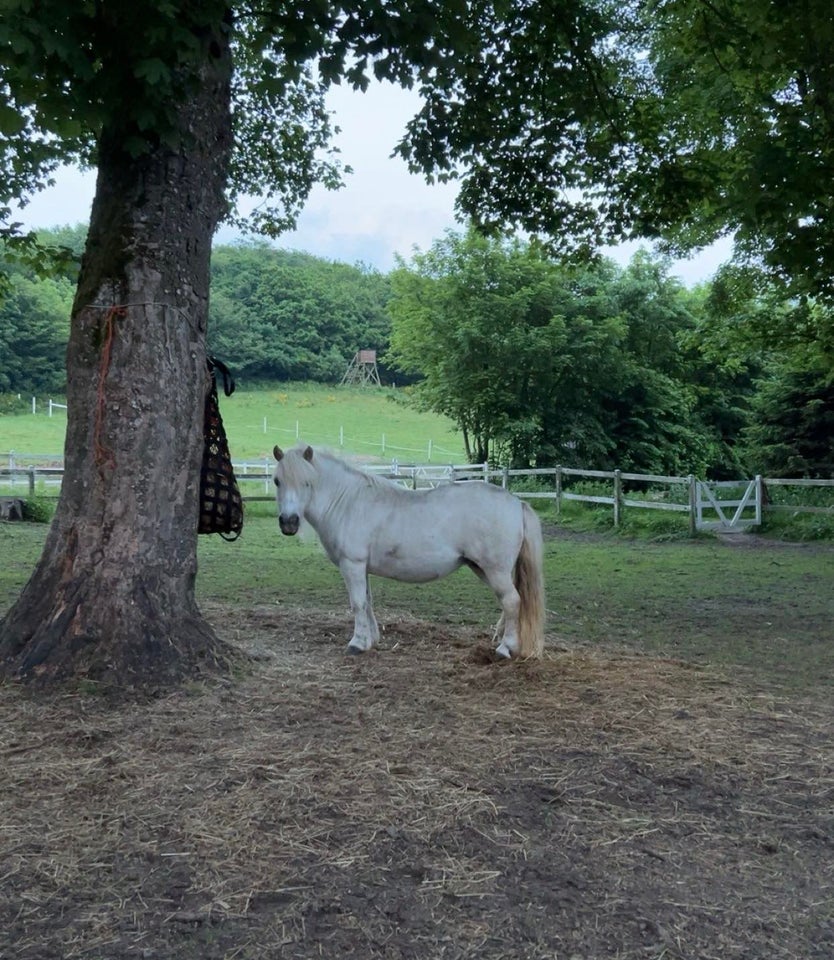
[0,505,834,691]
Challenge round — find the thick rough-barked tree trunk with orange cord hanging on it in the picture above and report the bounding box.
[0,24,236,688]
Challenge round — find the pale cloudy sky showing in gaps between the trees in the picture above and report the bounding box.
[13,84,729,286]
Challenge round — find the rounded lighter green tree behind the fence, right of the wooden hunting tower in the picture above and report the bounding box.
[389,230,621,464]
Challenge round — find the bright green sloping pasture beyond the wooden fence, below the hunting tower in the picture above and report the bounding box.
[0,383,465,463]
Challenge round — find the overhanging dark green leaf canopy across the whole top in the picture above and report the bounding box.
[6,0,834,298]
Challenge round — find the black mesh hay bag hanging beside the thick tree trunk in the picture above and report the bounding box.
[197,357,243,540]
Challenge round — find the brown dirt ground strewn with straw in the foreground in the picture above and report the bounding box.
[0,607,834,960]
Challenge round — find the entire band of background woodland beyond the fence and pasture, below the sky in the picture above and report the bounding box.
[0,227,834,478]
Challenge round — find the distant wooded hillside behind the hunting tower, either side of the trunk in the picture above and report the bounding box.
[0,226,396,394]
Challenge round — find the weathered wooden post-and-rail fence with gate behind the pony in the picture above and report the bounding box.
[0,460,834,534]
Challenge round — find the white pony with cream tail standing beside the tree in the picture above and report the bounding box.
[273,444,545,657]
